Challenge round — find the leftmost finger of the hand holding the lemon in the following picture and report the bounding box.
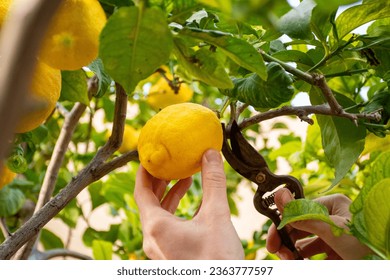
[134,165,165,218]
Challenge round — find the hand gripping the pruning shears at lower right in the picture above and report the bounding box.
[267,188,371,260]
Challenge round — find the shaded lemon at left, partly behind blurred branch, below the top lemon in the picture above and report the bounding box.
[16,61,61,133]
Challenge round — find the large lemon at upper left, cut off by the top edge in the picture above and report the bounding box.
[39,0,107,70]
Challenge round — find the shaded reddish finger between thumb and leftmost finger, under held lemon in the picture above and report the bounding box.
[161,178,192,214]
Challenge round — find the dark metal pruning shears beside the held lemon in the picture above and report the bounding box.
[222,121,304,259]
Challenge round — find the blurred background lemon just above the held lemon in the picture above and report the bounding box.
[146,77,193,110]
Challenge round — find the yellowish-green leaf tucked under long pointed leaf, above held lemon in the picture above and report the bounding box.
[174,38,233,89]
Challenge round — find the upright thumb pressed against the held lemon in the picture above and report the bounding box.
[200,149,230,215]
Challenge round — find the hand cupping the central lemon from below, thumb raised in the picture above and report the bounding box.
[134,150,244,259]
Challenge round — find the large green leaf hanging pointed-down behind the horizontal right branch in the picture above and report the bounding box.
[310,89,366,188]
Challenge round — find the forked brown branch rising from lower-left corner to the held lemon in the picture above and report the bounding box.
[0,84,131,259]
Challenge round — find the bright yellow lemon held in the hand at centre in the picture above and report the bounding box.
[138,103,223,180]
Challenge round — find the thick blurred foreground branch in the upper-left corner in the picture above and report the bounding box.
[0,0,61,167]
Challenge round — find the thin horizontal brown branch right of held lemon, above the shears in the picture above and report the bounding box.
[239,104,380,129]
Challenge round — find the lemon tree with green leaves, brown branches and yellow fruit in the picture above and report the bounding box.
[0,0,390,260]
